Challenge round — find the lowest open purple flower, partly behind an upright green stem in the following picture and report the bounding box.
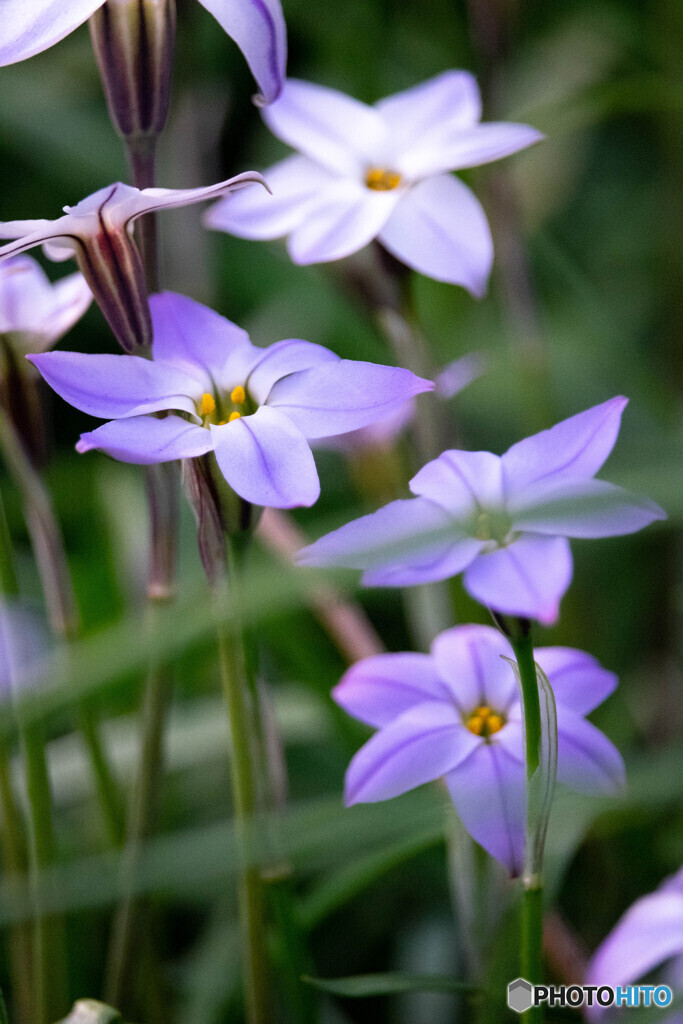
[333,626,625,874]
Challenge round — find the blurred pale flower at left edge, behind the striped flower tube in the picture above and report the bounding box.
[0,256,92,353]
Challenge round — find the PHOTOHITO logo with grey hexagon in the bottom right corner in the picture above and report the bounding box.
[508,978,673,1014]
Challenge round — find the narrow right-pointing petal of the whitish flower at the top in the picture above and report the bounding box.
[398,121,544,179]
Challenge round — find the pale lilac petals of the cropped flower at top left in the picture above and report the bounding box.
[0,0,287,103]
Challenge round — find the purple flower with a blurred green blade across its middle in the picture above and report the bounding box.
[298,397,666,623]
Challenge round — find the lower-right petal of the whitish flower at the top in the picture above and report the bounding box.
[379,174,494,298]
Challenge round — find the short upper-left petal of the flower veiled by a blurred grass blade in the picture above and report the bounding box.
[410,449,503,520]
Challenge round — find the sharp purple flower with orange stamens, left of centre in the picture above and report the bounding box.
[30,292,433,508]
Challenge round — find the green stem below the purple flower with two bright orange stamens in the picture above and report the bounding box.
[218,548,271,1024]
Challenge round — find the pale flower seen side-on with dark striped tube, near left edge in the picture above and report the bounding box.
[0,171,267,351]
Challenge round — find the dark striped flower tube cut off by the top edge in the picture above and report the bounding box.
[89,0,175,148]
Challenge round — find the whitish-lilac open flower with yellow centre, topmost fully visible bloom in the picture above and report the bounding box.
[206,71,542,295]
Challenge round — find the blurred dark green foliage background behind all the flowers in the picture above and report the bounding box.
[0,0,683,1024]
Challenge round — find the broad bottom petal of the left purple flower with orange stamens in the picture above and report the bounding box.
[211,406,321,509]
